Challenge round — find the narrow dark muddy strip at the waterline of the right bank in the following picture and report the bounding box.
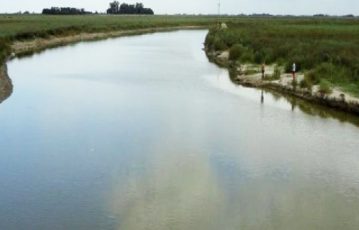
[205,47,359,115]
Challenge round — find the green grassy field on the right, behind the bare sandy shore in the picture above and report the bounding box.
[206,18,359,96]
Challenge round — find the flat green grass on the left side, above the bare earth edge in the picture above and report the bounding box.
[0,15,237,63]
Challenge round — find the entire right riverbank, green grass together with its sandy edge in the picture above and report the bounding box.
[205,18,359,114]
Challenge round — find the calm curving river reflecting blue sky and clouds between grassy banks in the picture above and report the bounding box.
[0,30,359,230]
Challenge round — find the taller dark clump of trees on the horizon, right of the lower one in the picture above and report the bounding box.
[107,1,154,15]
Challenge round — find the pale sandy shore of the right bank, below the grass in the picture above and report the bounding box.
[206,50,359,115]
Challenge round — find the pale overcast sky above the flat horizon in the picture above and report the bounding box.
[0,0,359,15]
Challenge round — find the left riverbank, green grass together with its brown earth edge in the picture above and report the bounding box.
[0,14,222,102]
